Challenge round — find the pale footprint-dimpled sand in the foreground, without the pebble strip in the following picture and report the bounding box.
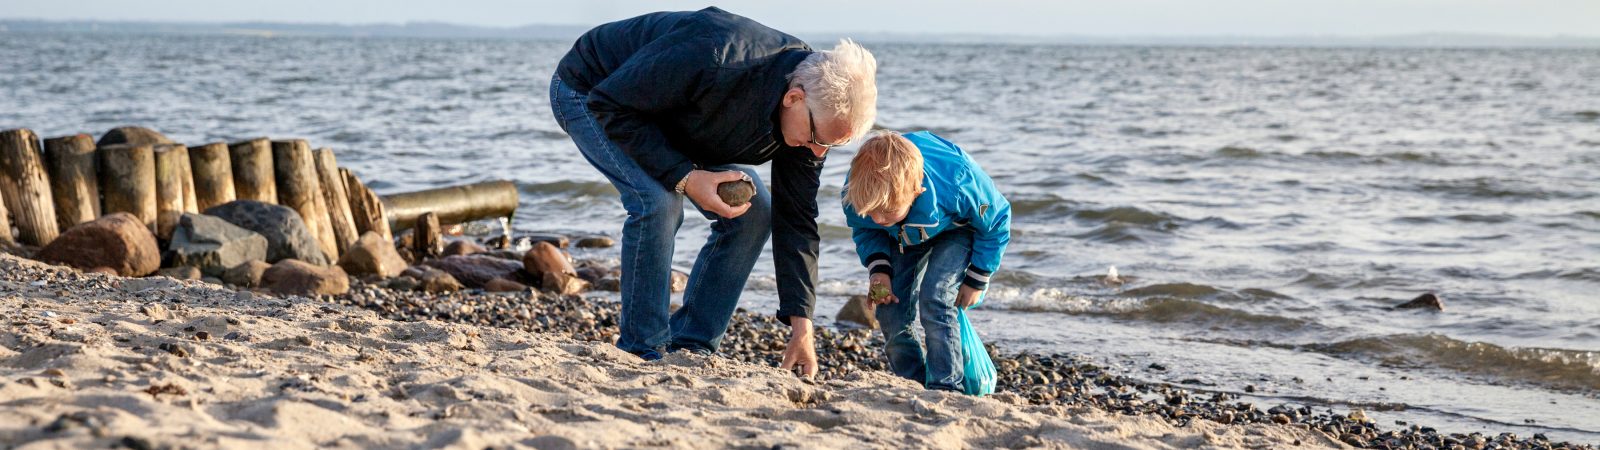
[0,255,1344,448]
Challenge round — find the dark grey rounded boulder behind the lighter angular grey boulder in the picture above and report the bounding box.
[205,200,333,266]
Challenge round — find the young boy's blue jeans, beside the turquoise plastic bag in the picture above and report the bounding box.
[877,226,973,391]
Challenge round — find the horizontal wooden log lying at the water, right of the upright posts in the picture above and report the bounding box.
[382,179,517,232]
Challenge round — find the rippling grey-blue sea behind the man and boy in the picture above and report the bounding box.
[0,34,1600,444]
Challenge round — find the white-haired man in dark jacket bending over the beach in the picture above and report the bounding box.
[550,8,877,376]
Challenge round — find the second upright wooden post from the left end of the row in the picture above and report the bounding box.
[45,133,99,231]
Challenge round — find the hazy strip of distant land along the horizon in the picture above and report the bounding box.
[0,19,1600,50]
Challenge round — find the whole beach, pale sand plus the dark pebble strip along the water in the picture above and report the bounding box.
[0,255,1589,448]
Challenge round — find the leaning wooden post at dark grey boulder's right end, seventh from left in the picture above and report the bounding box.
[272,139,342,259]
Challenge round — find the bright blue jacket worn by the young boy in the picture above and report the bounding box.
[840,131,1011,290]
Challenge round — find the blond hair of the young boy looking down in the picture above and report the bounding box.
[845,131,923,216]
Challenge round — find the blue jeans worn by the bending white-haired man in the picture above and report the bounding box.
[550,77,773,359]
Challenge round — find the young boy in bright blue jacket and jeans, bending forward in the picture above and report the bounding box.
[842,131,1011,391]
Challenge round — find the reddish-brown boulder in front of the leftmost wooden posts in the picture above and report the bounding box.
[34,213,162,277]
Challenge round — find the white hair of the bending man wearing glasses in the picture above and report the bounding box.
[789,38,878,141]
